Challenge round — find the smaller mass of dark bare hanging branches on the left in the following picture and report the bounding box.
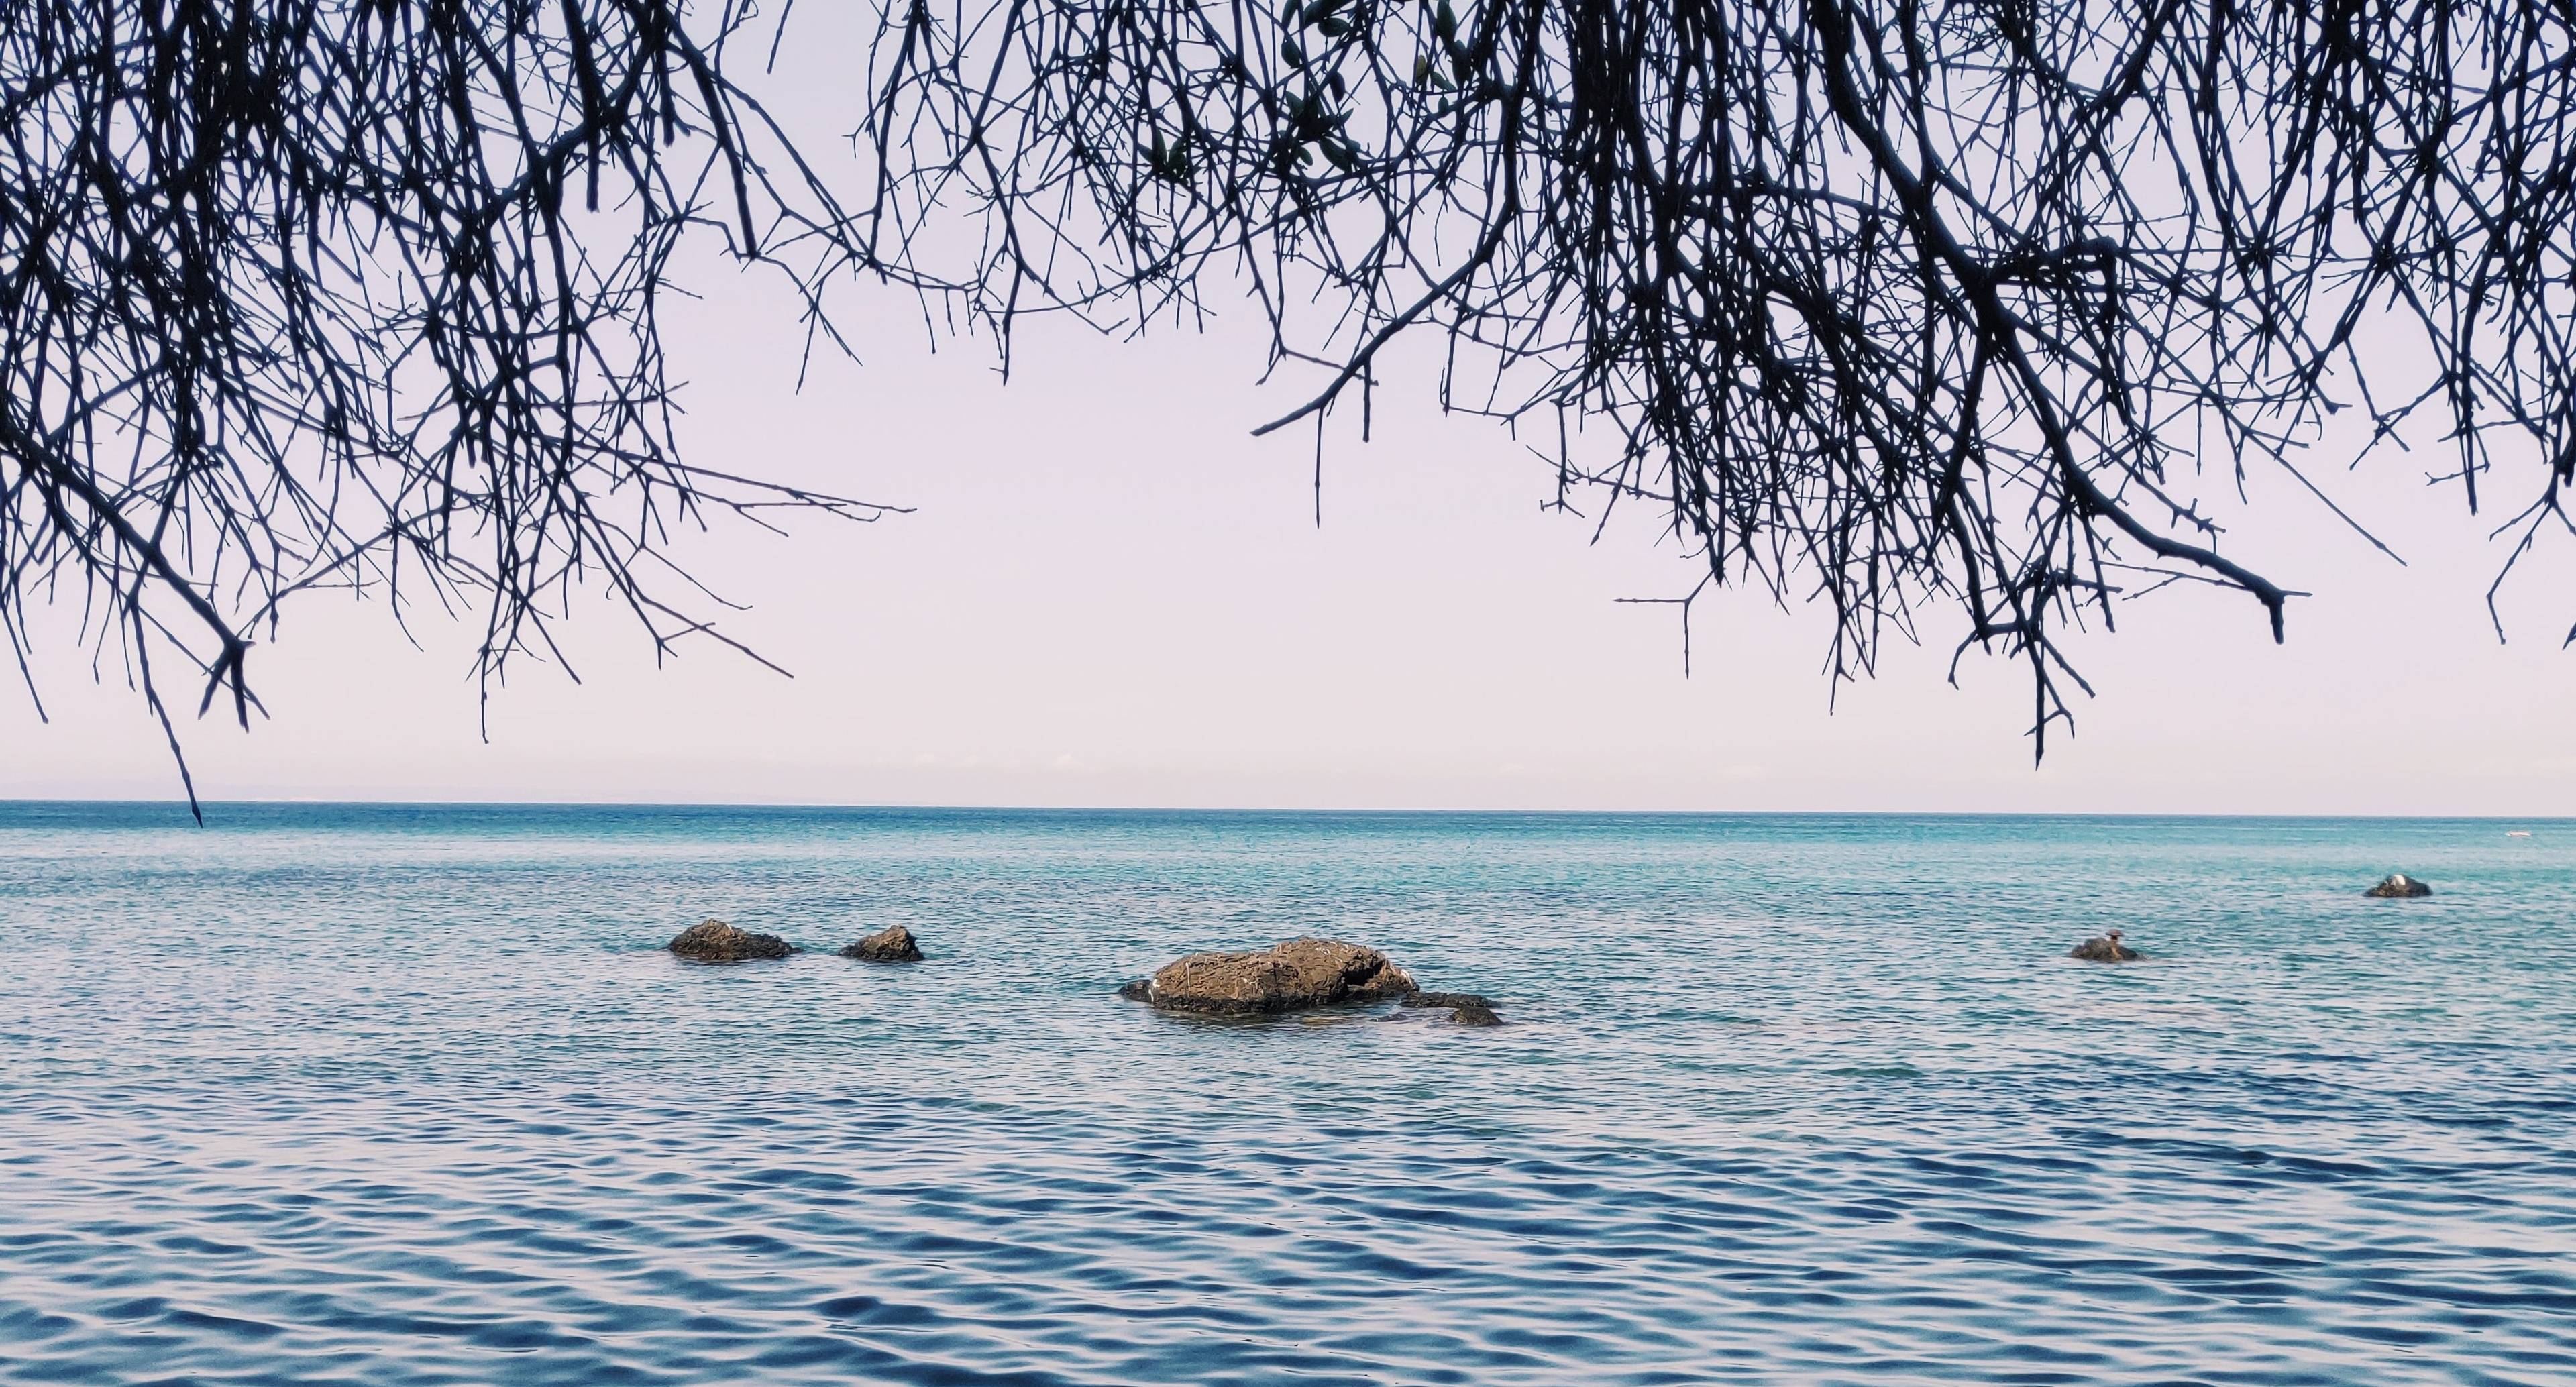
[0,0,906,803]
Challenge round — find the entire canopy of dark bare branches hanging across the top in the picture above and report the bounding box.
[0,0,2576,803]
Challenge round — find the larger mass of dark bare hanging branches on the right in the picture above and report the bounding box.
[868,0,2576,751]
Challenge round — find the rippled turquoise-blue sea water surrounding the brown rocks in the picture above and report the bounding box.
[0,806,2576,1387]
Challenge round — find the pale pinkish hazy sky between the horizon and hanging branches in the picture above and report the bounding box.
[0,51,2576,816]
